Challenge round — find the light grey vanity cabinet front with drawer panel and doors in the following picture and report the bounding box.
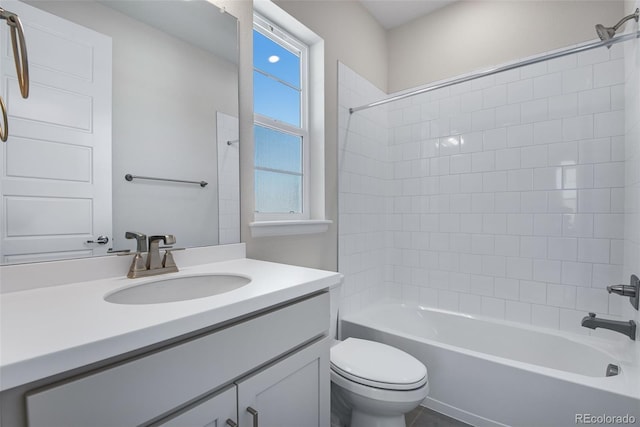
[20,292,329,427]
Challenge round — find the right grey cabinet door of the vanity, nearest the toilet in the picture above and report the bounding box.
[237,338,330,427]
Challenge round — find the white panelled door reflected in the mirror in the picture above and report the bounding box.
[0,1,112,263]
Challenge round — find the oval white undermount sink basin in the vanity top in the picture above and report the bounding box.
[104,274,251,304]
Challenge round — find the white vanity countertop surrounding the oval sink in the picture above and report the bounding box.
[0,258,342,391]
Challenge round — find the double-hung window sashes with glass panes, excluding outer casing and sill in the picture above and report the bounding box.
[253,15,310,220]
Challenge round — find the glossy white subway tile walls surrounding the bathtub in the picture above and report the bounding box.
[339,35,640,337]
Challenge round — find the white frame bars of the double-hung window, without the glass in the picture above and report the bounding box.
[253,12,311,221]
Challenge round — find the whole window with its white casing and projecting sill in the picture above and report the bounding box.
[249,0,331,237]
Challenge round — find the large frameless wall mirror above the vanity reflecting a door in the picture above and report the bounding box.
[0,0,240,264]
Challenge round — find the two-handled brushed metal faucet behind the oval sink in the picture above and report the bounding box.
[124,231,178,279]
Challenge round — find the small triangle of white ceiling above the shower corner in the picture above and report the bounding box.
[360,0,456,30]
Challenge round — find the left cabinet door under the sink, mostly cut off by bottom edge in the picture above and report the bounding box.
[159,386,238,427]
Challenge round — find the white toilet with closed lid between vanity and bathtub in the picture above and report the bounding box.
[330,285,429,427]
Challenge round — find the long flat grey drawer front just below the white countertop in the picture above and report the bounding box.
[26,293,329,427]
